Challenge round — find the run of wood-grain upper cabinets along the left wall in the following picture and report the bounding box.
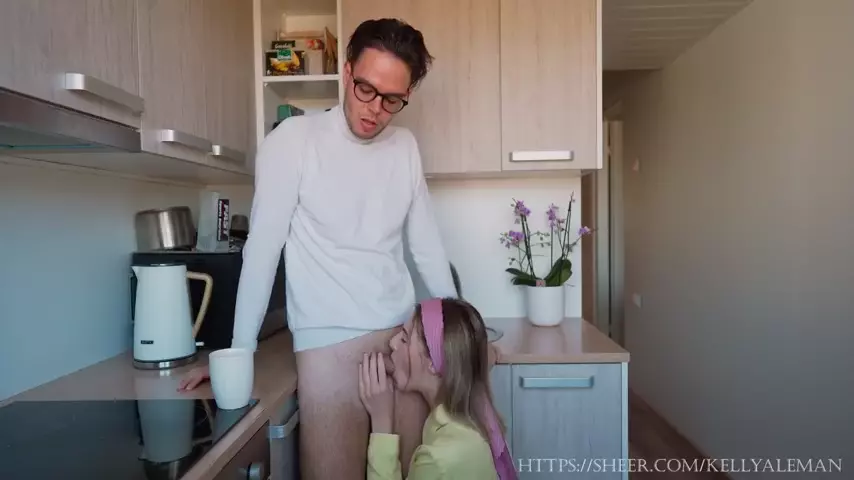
[0,0,255,183]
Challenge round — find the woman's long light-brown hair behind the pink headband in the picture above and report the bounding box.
[415,298,505,441]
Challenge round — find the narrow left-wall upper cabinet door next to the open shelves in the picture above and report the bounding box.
[204,0,253,165]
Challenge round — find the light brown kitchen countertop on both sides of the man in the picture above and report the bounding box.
[0,318,629,480]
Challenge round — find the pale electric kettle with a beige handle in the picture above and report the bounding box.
[131,263,213,370]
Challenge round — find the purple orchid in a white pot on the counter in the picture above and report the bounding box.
[500,193,592,326]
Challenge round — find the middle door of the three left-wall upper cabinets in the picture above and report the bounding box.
[138,0,211,163]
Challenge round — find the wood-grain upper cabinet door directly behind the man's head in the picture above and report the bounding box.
[342,0,501,175]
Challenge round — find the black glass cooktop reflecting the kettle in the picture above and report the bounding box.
[0,399,258,480]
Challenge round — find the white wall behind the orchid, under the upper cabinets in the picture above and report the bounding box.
[216,176,582,317]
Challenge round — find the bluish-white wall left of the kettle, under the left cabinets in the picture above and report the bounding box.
[0,157,198,399]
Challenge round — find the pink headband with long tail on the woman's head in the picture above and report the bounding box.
[421,298,517,480]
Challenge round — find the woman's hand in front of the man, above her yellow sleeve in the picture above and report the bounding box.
[359,352,394,433]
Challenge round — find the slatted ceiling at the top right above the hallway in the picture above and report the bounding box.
[602,0,751,70]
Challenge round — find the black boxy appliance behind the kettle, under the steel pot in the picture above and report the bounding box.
[131,251,287,350]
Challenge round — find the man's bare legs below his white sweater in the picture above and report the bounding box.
[296,327,429,480]
